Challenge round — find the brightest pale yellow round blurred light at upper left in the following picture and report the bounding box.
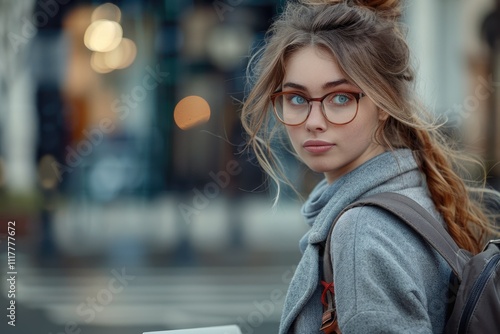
[83,20,123,52]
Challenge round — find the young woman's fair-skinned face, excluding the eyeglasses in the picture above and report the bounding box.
[282,46,387,183]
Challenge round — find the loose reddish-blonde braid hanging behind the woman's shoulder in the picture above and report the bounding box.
[375,115,498,254]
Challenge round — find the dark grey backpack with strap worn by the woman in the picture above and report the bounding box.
[320,193,500,334]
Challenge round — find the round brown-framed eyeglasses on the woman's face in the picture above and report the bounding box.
[271,92,366,126]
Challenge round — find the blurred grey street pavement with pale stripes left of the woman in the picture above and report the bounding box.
[0,197,305,334]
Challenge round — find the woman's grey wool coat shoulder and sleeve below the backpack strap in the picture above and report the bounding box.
[330,193,451,332]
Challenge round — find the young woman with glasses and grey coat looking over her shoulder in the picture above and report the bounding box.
[242,0,493,333]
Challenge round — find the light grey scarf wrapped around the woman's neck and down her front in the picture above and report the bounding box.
[280,149,422,333]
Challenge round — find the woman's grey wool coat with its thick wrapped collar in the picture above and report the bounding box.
[280,150,451,334]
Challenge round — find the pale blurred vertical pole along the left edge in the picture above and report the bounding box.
[0,0,37,193]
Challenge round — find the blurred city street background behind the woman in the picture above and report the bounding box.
[0,0,500,334]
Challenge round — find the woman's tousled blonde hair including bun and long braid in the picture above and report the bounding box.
[241,0,494,253]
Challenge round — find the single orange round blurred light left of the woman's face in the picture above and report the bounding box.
[174,95,210,130]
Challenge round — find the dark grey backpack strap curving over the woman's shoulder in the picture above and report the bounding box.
[323,193,468,288]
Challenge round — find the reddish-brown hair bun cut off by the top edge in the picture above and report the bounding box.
[302,0,402,20]
